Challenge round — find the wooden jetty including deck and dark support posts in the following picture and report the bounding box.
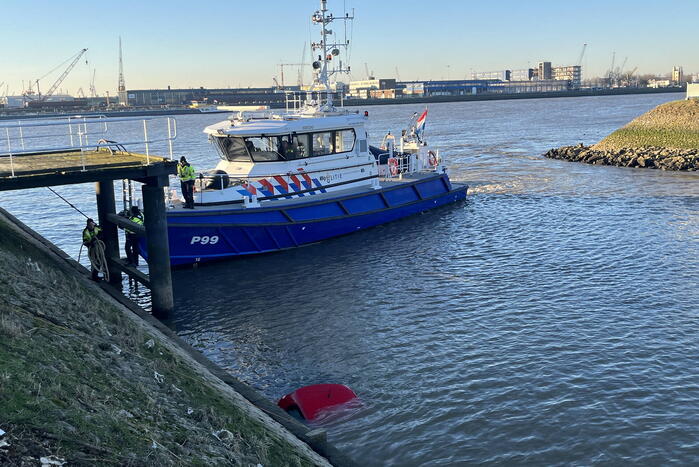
[0,144,177,316]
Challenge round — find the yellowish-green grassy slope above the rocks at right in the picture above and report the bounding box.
[592,99,699,150]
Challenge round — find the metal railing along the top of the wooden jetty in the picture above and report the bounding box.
[0,115,177,177]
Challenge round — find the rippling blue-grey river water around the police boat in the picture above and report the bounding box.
[0,94,699,465]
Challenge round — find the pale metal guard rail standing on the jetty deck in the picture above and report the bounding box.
[0,115,177,177]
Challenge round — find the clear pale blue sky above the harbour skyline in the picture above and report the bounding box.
[0,0,699,95]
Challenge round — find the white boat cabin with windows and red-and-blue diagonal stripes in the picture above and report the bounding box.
[195,112,378,205]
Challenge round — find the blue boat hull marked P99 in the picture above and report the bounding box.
[154,175,467,266]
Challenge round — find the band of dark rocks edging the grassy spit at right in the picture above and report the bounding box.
[544,143,699,171]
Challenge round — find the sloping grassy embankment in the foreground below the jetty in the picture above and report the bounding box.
[0,216,324,465]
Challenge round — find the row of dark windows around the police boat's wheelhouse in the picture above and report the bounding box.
[214,128,356,162]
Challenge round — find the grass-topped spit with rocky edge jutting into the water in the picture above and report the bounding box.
[544,100,699,171]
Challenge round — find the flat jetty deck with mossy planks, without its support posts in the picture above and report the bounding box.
[0,148,177,191]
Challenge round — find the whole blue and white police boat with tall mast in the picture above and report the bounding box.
[156,0,467,266]
